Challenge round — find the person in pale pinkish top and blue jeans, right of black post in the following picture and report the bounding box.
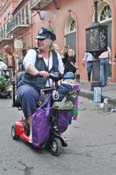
[99,47,111,87]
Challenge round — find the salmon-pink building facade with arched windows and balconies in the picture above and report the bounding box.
[0,0,116,82]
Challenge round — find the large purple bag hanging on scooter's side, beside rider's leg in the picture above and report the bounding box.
[32,95,51,147]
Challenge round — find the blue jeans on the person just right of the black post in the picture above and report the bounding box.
[100,58,109,86]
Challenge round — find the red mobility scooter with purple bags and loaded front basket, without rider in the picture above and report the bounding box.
[11,72,79,156]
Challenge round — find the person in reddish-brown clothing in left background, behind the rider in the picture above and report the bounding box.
[4,45,18,81]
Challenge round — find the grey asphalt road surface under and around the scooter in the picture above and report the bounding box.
[0,97,116,175]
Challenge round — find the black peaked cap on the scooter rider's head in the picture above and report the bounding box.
[36,27,56,41]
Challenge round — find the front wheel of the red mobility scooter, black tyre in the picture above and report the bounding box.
[49,138,62,156]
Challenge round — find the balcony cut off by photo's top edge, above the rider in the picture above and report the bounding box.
[31,0,53,10]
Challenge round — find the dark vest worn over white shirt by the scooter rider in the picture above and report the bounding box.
[21,50,59,90]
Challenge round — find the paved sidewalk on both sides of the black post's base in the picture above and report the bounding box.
[79,80,116,108]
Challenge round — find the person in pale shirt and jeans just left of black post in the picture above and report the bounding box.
[83,52,93,82]
